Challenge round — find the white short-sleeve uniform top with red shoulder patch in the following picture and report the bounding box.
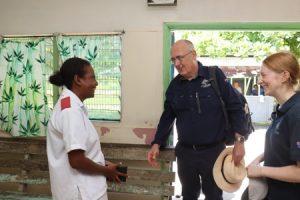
[47,88,107,200]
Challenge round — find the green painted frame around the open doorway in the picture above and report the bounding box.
[163,22,300,96]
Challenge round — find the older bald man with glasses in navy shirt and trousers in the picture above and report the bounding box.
[148,40,246,200]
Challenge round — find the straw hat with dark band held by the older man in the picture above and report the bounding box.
[213,147,246,192]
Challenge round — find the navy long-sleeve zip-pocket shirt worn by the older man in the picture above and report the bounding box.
[152,62,246,145]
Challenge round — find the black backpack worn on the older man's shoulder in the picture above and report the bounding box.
[208,66,254,145]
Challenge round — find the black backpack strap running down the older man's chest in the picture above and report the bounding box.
[207,66,230,130]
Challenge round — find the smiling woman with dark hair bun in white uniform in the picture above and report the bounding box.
[47,57,126,200]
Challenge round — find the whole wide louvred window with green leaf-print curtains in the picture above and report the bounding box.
[0,33,122,136]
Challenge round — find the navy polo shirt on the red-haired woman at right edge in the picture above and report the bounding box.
[264,93,300,200]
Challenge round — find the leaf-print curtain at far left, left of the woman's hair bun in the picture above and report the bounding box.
[0,38,53,136]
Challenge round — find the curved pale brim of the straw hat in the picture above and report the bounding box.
[213,147,242,193]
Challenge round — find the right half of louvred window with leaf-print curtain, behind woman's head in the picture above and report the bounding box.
[57,34,121,120]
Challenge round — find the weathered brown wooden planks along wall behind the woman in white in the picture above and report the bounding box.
[0,138,175,199]
